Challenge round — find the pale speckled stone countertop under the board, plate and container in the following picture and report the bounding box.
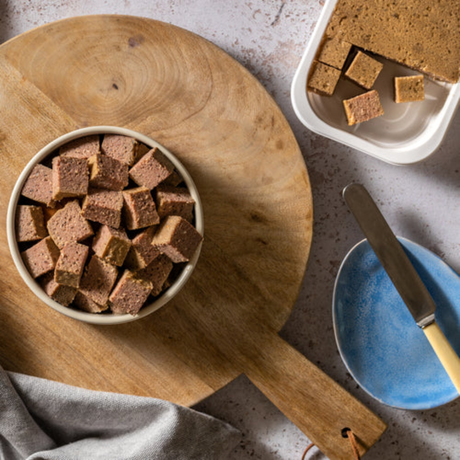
[0,0,460,460]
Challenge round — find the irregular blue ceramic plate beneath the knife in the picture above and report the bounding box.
[333,238,460,410]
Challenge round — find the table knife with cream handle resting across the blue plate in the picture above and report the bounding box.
[342,184,460,393]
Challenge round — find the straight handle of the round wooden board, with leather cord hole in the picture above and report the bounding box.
[241,331,386,460]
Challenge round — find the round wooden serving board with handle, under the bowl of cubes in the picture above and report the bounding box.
[0,15,385,459]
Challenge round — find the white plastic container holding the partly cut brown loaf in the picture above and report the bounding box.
[291,0,460,165]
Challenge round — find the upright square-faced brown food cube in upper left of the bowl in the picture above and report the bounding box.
[53,157,88,201]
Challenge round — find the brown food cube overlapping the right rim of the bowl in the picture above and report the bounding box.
[152,216,203,263]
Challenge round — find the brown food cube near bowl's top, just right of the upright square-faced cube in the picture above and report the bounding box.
[88,154,129,191]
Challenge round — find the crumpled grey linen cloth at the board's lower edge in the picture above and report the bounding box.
[0,367,240,460]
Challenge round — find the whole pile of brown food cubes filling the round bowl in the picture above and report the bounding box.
[16,134,202,315]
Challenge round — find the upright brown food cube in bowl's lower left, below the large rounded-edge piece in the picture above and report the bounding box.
[54,243,89,288]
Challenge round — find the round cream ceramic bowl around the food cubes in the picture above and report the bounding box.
[6,126,204,324]
